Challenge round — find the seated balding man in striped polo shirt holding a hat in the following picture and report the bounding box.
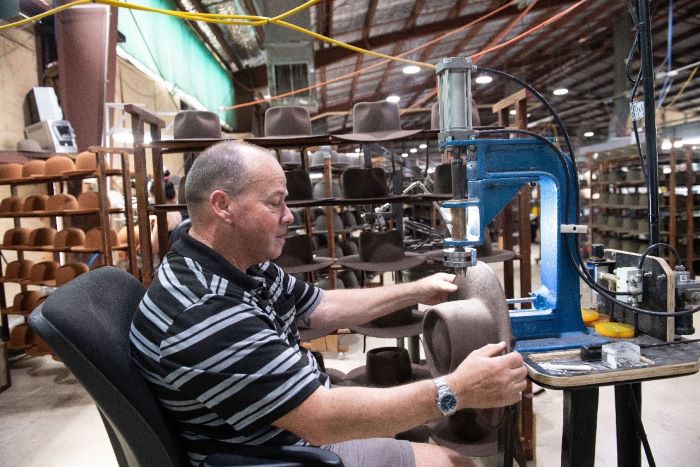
[131,142,526,467]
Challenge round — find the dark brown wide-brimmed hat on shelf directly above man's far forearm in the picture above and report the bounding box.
[339,230,425,272]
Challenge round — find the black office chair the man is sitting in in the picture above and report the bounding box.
[29,267,342,467]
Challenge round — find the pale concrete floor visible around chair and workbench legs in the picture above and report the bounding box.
[0,258,700,467]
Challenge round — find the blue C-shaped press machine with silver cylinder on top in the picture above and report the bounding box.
[437,57,608,352]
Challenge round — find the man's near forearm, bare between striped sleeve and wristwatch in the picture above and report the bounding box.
[275,380,440,445]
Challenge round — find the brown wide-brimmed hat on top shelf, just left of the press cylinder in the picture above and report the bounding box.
[334,101,423,142]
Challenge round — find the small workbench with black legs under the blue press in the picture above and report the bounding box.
[523,335,700,467]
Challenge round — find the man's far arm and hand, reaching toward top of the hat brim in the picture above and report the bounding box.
[302,273,457,330]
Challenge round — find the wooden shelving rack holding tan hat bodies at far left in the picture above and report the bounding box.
[0,150,135,355]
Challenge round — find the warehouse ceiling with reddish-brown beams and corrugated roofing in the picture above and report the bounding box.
[177,0,700,145]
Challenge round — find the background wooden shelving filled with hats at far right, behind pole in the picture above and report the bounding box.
[581,145,700,273]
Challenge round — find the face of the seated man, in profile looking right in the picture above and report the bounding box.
[234,157,294,267]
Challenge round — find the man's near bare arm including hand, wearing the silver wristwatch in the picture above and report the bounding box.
[273,342,527,445]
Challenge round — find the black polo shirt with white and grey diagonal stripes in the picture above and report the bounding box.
[130,234,330,464]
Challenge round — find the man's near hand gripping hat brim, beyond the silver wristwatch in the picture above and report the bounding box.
[446,342,527,409]
